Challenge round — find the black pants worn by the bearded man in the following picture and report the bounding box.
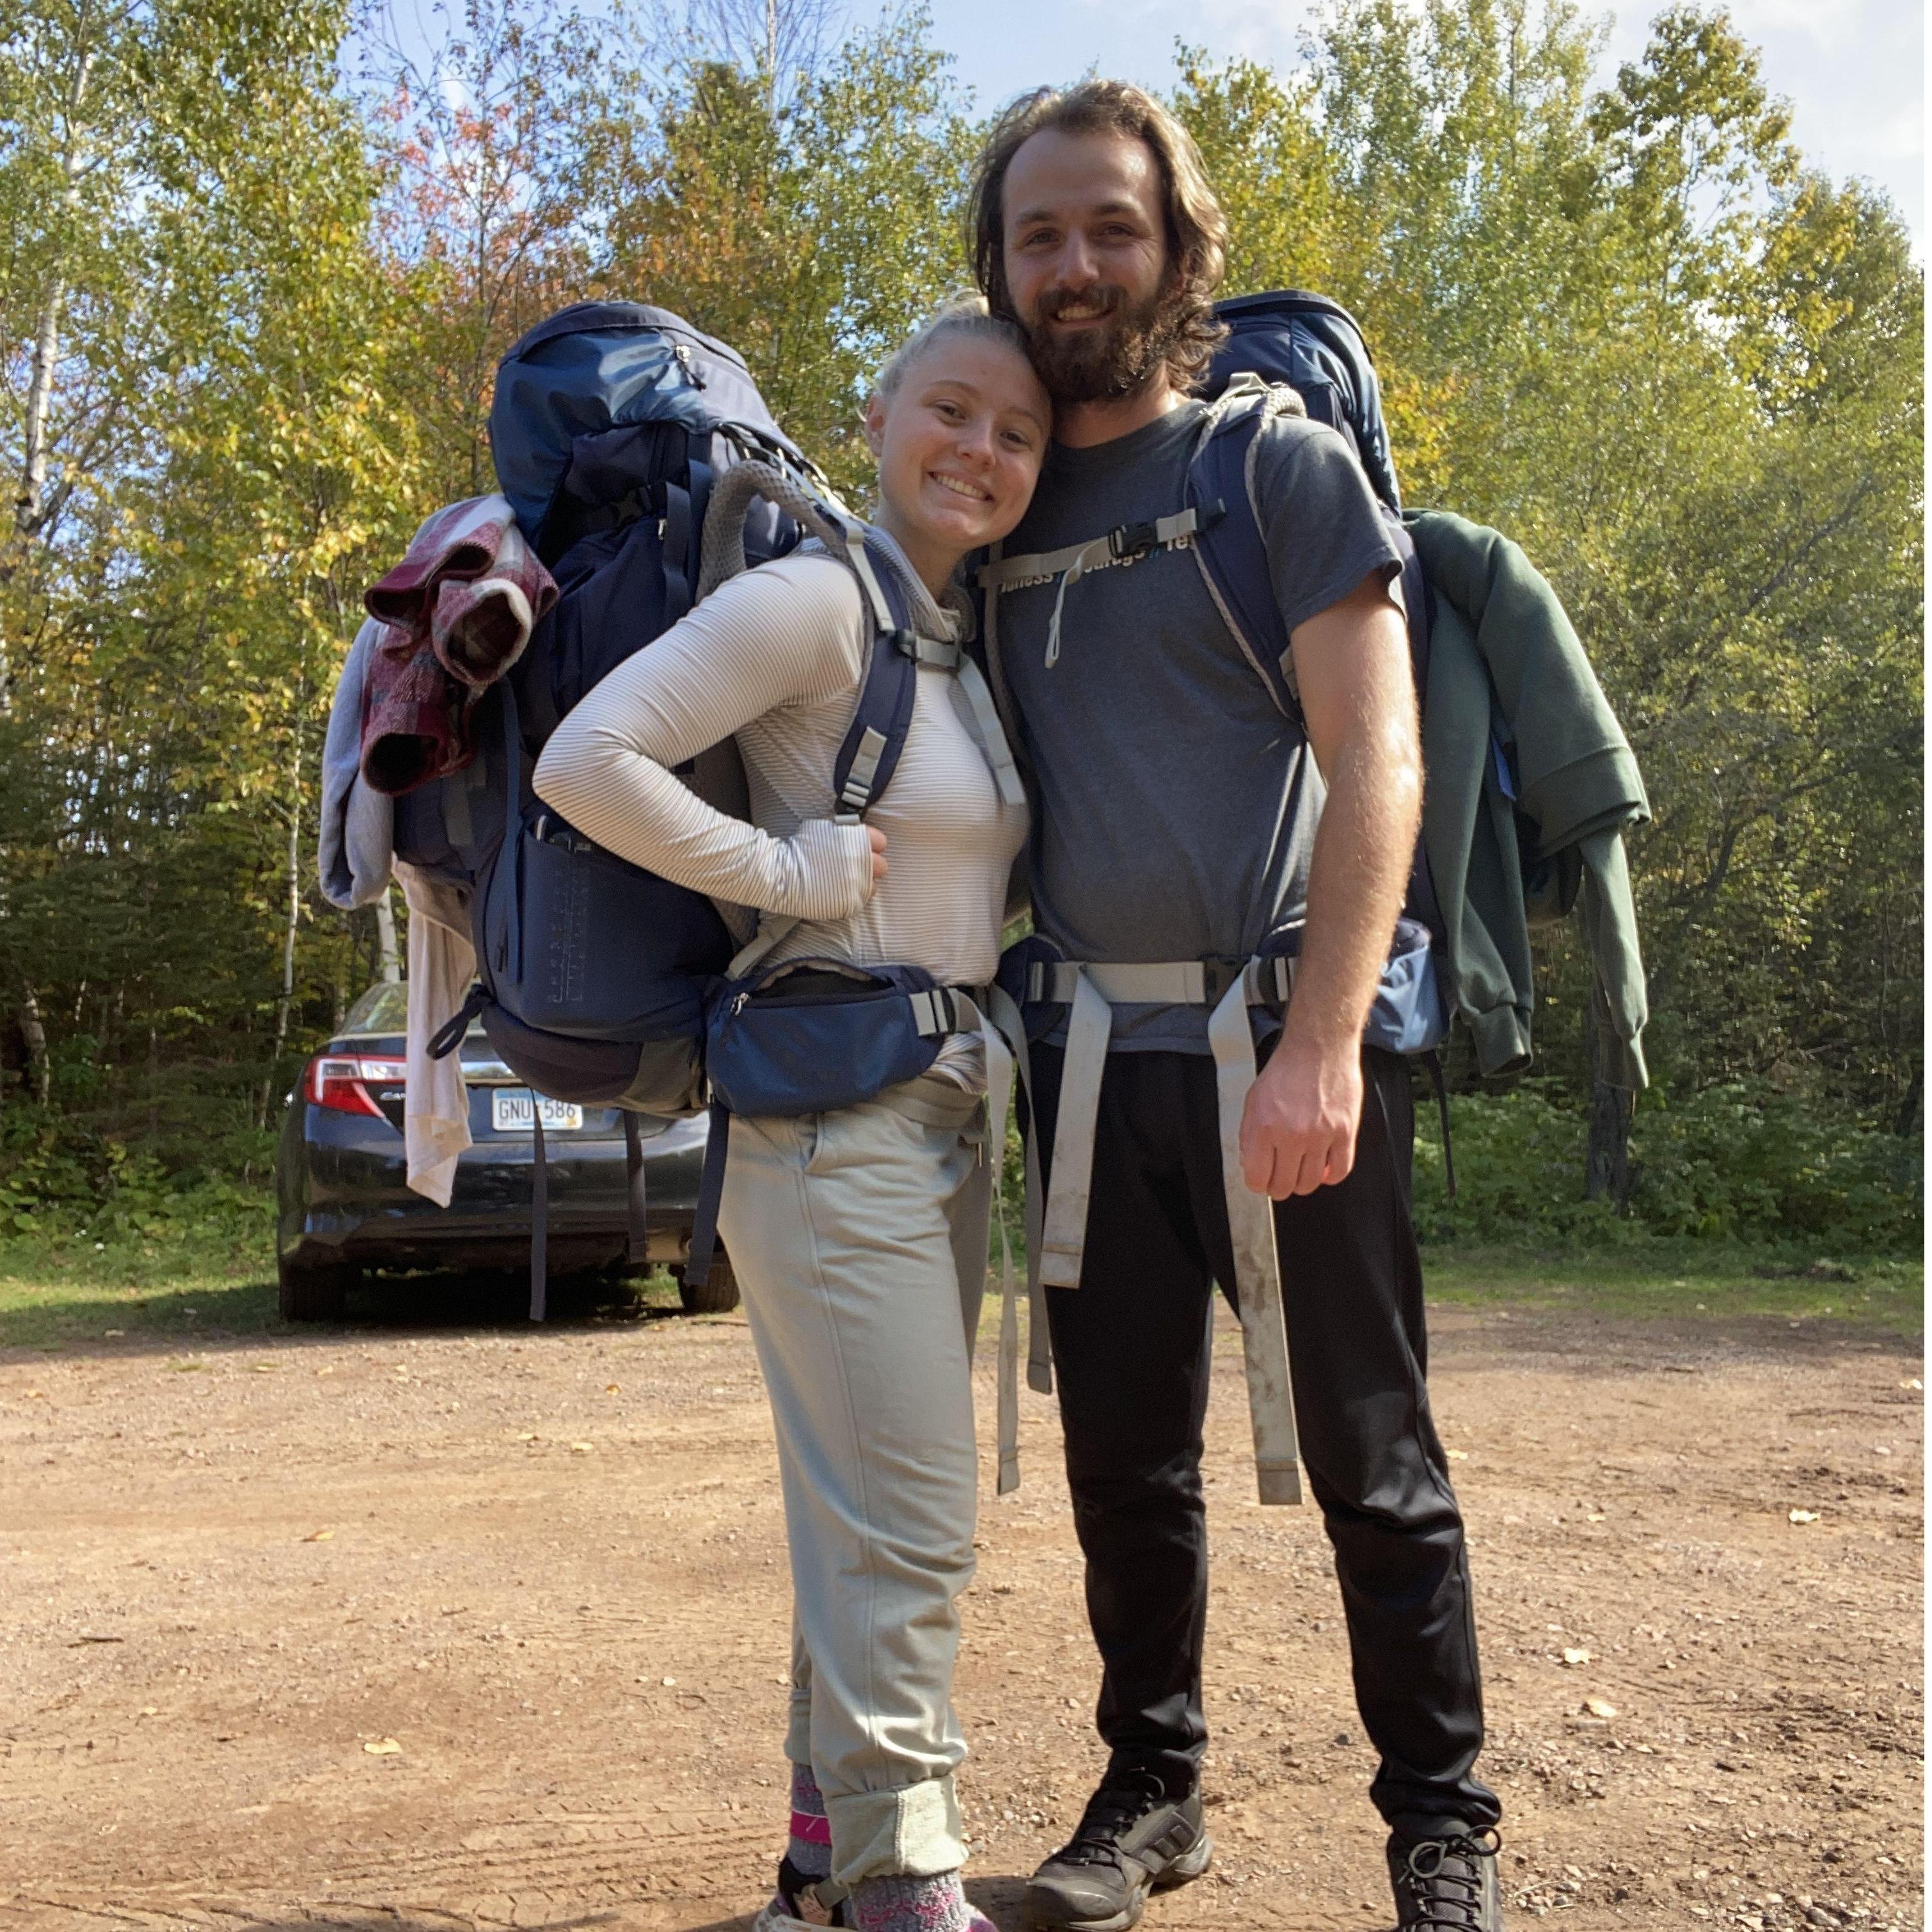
[1032,1047,1500,1837]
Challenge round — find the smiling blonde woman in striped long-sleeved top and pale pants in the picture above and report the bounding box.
[535,299,1051,1932]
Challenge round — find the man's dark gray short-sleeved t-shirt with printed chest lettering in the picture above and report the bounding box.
[997,402,1401,1053]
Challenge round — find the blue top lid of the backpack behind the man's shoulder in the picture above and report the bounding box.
[1201,288,1403,510]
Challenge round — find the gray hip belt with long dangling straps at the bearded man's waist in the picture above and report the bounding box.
[1026,958,1302,1503]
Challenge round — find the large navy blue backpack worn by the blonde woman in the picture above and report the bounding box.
[413,301,942,1316]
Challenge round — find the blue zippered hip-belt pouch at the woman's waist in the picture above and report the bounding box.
[705,958,953,1115]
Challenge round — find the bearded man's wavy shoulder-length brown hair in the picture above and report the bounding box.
[968,81,1227,390]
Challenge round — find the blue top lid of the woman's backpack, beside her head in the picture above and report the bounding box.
[489,301,805,541]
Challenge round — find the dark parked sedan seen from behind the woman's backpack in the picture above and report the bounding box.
[276,983,738,1322]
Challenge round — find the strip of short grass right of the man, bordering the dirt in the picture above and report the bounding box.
[1422,1239,1924,1337]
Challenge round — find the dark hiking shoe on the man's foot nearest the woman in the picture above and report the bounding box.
[1026,1771,1214,1932]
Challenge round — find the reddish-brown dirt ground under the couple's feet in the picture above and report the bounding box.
[0,1283,1924,1932]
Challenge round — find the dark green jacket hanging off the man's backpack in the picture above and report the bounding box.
[1403,510,1650,1091]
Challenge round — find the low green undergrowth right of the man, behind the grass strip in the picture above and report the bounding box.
[1416,1084,1924,1254]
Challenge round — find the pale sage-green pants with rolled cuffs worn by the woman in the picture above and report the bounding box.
[718,1074,999,1886]
